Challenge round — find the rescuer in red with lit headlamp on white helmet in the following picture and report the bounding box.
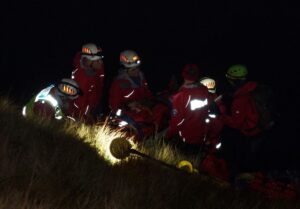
[109,50,168,138]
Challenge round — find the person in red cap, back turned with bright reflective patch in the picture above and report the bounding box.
[166,64,209,155]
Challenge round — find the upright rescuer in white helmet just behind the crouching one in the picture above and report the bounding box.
[71,43,105,123]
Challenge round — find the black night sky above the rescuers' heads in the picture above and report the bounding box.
[0,0,300,168]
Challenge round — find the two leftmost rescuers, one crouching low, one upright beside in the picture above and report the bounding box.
[23,43,104,122]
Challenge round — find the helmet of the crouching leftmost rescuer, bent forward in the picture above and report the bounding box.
[57,78,81,99]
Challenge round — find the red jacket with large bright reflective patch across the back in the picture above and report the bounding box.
[166,84,209,144]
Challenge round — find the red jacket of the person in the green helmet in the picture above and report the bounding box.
[221,81,261,136]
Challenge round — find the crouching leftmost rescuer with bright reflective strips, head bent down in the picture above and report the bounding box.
[22,78,81,120]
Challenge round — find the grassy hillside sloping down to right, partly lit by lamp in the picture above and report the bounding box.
[0,98,300,209]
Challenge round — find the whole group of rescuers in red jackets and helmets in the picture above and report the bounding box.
[23,43,276,184]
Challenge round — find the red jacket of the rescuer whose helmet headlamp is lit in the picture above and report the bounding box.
[109,71,153,111]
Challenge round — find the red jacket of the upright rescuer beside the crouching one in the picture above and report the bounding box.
[72,51,105,117]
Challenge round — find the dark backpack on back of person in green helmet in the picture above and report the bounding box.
[250,84,278,131]
